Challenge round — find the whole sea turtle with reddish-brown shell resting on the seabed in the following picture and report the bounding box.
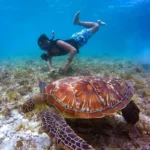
[22,76,139,150]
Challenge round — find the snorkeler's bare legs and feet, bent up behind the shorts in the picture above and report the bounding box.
[73,11,106,33]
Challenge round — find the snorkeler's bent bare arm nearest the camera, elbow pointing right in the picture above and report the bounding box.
[57,40,77,72]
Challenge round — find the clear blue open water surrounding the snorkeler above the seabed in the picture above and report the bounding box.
[0,0,150,63]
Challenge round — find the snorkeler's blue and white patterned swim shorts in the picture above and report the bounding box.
[71,29,92,47]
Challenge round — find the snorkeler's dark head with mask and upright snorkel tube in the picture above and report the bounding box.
[38,31,55,51]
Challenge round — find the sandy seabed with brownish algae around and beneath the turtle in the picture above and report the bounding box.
[0,57,150,150]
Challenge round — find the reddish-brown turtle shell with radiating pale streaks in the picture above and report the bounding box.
[44,76,134,118]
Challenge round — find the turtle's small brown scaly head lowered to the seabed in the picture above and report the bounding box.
[21,98,35,113]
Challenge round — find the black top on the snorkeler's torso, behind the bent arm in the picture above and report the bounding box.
[48,39,79,56]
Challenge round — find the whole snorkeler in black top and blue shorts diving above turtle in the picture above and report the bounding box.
[38,11,106,73]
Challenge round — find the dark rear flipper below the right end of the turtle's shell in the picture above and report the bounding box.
[122,101,140,125]
